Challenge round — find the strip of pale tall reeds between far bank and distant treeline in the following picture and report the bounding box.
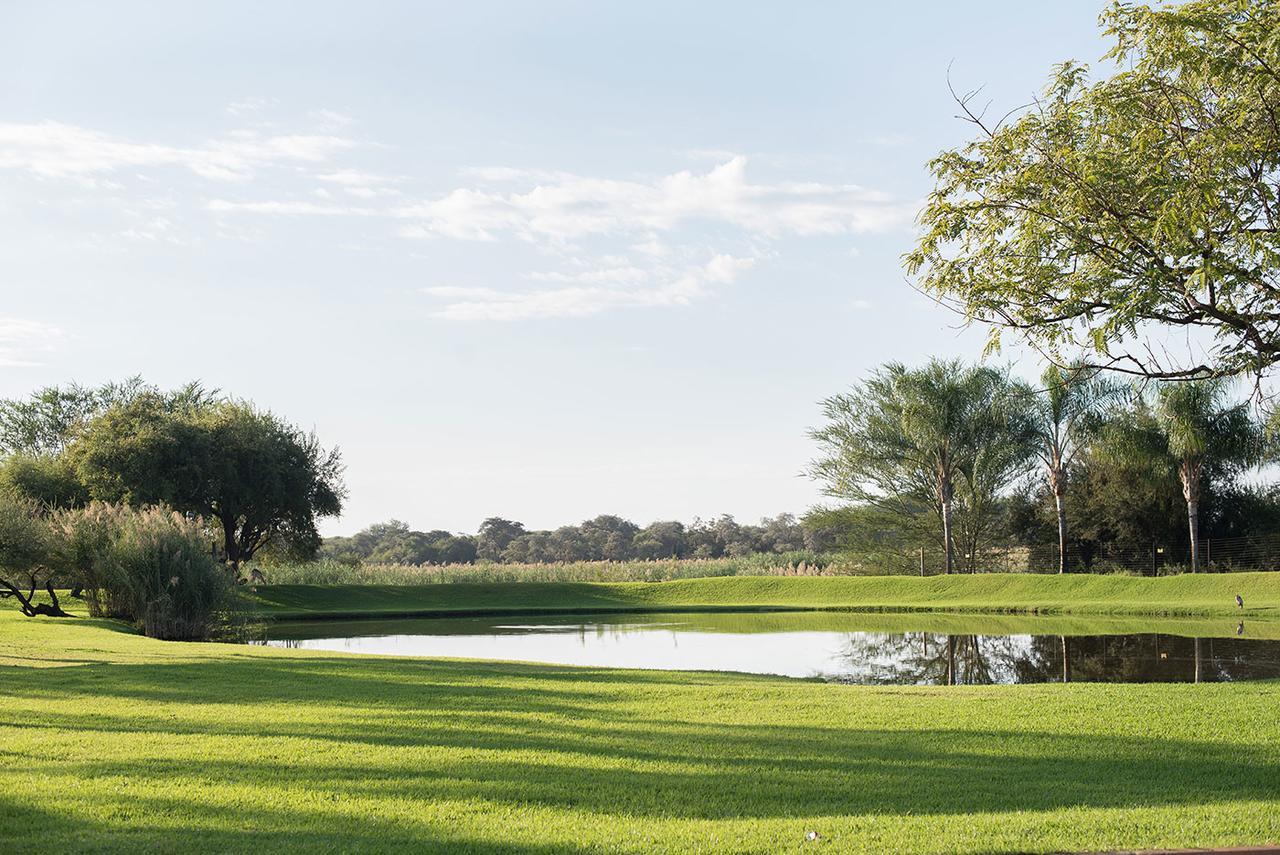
[264,552,859,585]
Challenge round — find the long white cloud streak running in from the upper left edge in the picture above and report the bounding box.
[0,122,356,180]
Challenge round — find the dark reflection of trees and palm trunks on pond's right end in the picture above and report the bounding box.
[832,632,1280,686]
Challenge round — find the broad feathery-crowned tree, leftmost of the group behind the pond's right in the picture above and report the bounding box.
[810,360,1032,573]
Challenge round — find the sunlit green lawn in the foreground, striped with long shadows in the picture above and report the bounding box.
[0,604,1280,852]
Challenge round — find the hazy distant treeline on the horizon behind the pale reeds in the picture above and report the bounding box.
[320,513,833,564]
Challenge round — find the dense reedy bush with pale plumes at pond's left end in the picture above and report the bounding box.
[54,502,236,640]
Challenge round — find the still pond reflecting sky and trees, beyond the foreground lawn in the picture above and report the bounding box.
[257,612,1280,685]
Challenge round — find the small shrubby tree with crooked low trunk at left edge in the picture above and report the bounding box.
[0,493,68,617]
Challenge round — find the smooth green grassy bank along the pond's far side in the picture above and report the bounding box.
[252,573,1280,619]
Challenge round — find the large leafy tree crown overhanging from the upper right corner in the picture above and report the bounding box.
[905,0,1280,378]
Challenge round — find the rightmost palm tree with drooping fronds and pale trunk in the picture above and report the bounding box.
[1105,378,1266,573]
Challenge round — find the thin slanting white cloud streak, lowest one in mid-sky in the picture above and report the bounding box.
[422,255,755,321]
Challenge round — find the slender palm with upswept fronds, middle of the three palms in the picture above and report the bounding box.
[1030,365,1121,573]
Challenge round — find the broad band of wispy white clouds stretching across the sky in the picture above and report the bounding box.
[0,115,915,320]
